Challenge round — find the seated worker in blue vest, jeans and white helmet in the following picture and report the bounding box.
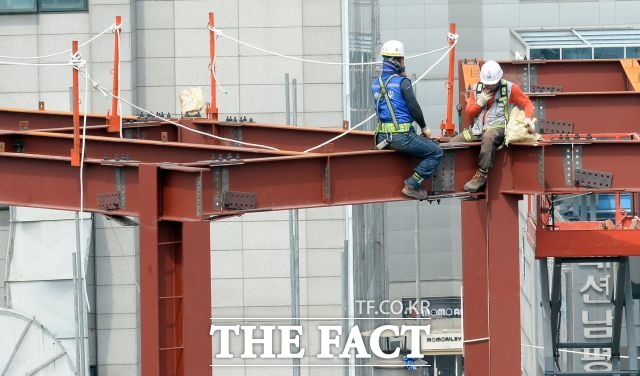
[371,40,442,200]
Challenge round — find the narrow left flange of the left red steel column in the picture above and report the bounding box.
[138,164,160,376]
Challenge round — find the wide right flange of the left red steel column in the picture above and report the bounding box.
[182,222,213,375]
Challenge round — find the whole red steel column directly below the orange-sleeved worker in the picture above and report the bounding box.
[462,153,521,376]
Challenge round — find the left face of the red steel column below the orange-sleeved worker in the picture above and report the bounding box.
[462,200,489,376]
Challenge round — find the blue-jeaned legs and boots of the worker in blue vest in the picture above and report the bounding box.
[391,133,443,200]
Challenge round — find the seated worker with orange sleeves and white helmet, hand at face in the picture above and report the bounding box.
[451,60,534,192]
